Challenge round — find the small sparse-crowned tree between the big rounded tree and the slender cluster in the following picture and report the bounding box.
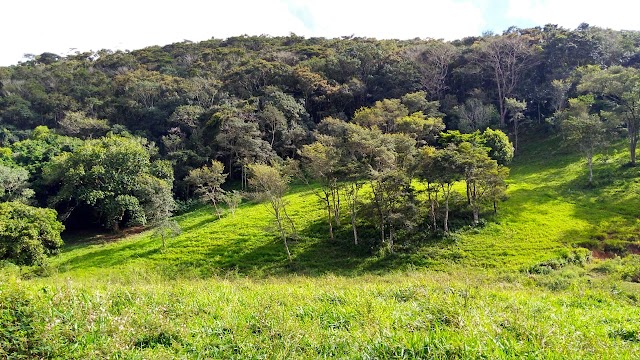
[185,160,228,219]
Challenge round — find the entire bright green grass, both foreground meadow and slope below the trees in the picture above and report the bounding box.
[0,136,640,359]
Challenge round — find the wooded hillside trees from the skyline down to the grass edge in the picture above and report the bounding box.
[0,24,640,262]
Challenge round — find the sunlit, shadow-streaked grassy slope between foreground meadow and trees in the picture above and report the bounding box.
[42,136,640,278]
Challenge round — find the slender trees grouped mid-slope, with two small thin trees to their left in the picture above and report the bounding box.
[182,93,513,258]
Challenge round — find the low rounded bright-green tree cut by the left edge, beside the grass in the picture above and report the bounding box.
[0,202,64,265]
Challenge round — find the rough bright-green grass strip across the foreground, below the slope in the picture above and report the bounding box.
[0,268,640,359]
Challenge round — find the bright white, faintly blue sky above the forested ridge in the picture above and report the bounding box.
[0,0,640,66]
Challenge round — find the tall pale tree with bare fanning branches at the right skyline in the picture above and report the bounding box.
[475,34,534,126]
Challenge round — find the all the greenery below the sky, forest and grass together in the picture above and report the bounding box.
[0,24,640,358]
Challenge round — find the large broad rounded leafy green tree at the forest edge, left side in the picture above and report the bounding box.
[44,135,173,231]
